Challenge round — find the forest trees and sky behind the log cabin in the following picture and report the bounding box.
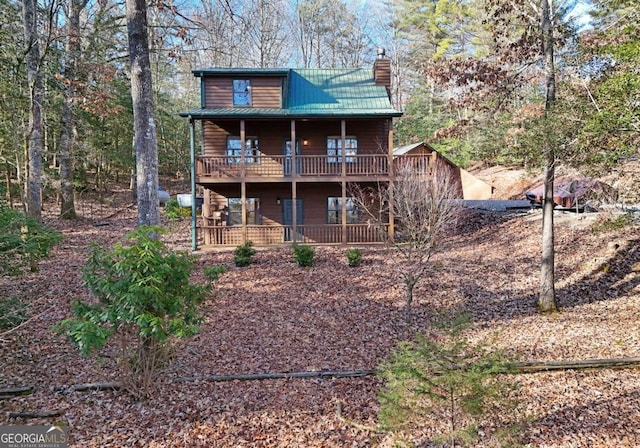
[0,0,640,216]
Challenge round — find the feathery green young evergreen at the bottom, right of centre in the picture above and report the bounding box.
[379,315,518,447]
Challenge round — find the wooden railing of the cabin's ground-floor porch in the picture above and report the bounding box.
[198,224,384,246]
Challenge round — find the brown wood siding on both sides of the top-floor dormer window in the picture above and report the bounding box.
[204,77,282,109]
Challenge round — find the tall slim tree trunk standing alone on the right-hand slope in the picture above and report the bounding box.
[538,0,558,313]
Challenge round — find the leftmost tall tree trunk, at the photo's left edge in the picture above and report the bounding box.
[22,0,44,221]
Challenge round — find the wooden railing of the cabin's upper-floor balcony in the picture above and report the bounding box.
[196,154,396,179]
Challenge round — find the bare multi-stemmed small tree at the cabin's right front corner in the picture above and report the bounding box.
[349,162,460,314]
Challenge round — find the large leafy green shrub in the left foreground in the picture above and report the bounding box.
[54,226,210,398]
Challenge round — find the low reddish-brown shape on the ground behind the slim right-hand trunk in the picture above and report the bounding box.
[525,177,618,211]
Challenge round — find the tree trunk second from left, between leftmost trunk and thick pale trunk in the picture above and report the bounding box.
[60,0,86,219]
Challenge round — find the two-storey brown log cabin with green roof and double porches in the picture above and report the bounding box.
[180,51,444,250]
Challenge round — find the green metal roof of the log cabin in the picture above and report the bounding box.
[180,68,402,118]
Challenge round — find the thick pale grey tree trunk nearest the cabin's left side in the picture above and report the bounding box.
[126,0,160,225]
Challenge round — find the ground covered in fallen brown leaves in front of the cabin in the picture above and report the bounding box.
[0,198,640,448]
